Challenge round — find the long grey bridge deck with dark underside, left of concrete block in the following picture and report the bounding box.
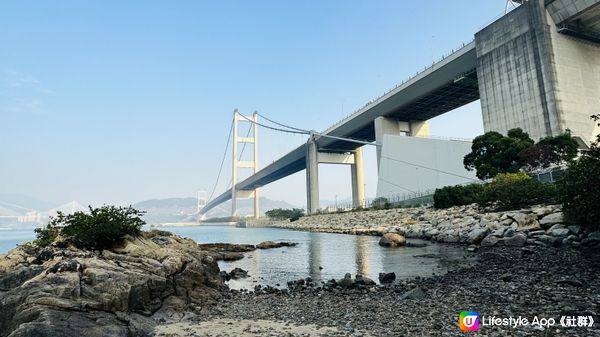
[201,42,479,213]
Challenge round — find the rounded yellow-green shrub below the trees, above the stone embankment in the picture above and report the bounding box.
[479,172,556,210]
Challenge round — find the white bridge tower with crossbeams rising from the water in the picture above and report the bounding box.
[231,109,260,219]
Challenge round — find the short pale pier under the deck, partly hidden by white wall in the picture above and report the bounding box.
[374,117,429,172]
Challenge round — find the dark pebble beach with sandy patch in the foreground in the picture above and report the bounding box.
[157,247,600,337]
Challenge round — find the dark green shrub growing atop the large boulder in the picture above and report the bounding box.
[36,206,145,249]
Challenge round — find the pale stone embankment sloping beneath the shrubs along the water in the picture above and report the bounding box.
[273,204,600,247]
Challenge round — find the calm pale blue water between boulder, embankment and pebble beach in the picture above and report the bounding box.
[0,225,471,289]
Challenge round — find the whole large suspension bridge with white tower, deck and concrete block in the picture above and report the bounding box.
[199,0,600,217]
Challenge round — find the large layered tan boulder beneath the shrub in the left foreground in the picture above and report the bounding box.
[0,232,224,337]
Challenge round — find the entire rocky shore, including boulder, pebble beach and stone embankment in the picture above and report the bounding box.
[0,205,600,337]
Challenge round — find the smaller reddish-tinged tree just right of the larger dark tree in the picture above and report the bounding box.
[519,133,579,171]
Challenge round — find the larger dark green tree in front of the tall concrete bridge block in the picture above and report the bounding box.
[463,128,534,180]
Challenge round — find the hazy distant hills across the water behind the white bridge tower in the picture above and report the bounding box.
[133,197,297,224]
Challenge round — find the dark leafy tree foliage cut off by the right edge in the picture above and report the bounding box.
[558,115,600,229]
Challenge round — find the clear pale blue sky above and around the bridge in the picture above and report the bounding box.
[0,0,506,206]
